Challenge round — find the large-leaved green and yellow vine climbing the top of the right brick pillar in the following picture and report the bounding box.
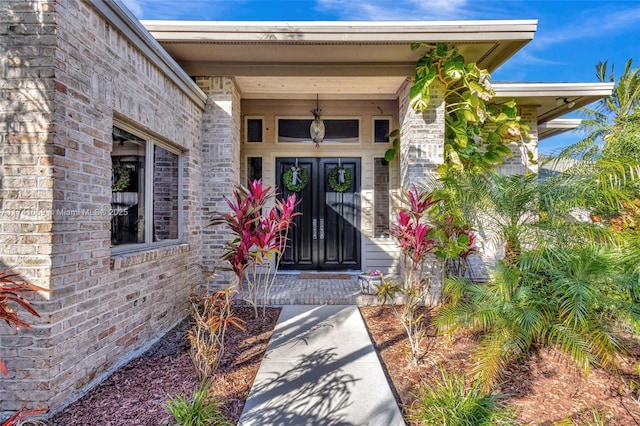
[408,43,533,176]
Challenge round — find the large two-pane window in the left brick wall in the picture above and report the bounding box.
[111,126,182,251]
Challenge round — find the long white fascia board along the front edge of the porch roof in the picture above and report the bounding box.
[141,20,538,43]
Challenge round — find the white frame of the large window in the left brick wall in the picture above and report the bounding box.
[109,120,184,255]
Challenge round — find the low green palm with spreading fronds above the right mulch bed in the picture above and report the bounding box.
[434,246,640,389]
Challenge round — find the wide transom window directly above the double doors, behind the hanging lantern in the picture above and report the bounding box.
[277,118,360,143]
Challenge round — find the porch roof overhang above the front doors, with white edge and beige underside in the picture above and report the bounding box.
[142,20,537,99]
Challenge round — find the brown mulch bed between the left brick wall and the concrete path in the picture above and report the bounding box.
[51,307,280,426]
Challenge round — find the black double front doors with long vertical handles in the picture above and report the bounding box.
[276,158,360,271]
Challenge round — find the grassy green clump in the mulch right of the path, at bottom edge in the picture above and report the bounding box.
[410,368,517,426]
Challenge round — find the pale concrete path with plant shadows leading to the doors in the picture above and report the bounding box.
[239,305,405,426]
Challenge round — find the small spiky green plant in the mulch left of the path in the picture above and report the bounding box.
[165,382,232,426]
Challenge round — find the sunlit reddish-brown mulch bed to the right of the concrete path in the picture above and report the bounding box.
[360,306,640,426]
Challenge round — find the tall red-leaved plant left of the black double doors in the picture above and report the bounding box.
[211,180,300,316]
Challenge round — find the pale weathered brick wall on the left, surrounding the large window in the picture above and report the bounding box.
[0,0,202,415]
